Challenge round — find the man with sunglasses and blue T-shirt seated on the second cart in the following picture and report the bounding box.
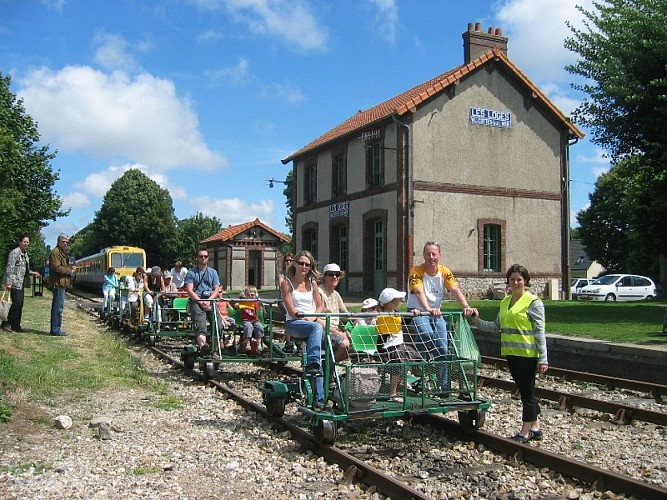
[185,249,222,356]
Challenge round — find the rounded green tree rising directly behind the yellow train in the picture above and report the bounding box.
[91,169,176,266]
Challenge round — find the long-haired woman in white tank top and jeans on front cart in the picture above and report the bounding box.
[280,250,325,408]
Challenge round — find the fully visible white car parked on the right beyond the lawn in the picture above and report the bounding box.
[577,274,656,302]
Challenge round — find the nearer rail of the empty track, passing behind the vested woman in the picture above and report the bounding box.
[477,375,667,426]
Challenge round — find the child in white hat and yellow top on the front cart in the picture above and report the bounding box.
[376,288,423,402]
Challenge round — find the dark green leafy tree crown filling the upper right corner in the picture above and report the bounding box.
[565,0,667,164]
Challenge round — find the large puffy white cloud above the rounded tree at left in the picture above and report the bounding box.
[18,66,227,170]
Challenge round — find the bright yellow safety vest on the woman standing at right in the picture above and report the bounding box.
[500,292,540,358]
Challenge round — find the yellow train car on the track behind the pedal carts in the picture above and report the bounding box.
[74,246,146,290]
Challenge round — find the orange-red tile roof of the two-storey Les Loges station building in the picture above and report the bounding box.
[282,47,584,164]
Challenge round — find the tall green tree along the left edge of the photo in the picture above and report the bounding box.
[0,73,68,278]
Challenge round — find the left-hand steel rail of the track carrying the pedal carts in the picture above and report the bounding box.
[148,346,431,500]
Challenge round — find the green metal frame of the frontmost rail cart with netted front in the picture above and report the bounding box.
[260,313,491,444]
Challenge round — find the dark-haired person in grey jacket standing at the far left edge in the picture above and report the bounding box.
[2,233,39,332]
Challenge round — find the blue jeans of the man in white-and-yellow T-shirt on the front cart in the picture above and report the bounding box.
[411,316,449,390]
